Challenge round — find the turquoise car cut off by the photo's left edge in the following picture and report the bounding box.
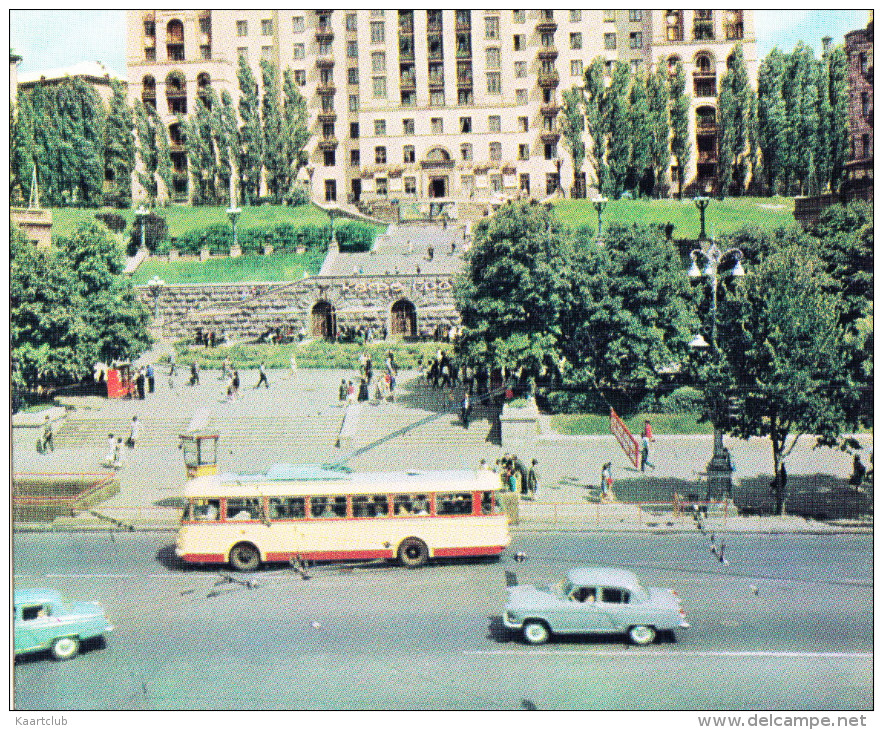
[12,588,113,661]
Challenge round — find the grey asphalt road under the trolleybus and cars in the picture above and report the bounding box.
[14,533,873,711]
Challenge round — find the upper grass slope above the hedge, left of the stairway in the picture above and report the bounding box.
[52,205,329,238]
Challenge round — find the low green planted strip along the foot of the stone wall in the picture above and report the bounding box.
[177,340,439,371]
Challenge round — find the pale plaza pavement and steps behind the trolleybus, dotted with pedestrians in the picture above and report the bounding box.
[12,366,873,532]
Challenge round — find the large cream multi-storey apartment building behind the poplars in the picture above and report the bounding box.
[127,9,757,202]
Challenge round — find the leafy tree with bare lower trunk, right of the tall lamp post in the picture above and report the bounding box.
[714,246,855,512]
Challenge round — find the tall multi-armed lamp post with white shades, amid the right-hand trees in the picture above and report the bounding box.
[687,242,745,496]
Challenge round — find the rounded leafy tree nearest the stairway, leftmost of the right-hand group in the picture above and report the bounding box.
[455,202,573,373]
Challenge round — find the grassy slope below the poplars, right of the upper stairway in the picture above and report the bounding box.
[555,197,795,238]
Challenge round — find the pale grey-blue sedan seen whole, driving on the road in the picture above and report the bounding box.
[503,566,690,644]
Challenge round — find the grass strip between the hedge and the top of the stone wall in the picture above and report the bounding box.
[132,251,325,284]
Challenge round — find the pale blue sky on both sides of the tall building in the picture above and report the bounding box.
[9,10,868,76]
